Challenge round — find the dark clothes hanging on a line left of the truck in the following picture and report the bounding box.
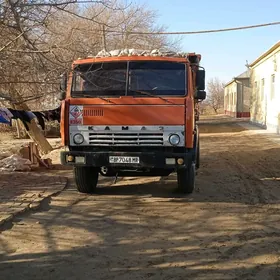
[0,106,61,131]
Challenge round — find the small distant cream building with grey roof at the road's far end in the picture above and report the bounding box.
[224,70,251,118]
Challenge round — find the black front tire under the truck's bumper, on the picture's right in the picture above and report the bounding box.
[177,162,195,193]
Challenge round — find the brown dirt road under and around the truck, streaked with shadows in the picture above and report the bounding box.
[0,115,280,280]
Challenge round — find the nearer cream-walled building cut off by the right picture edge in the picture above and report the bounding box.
[249,41,280,133]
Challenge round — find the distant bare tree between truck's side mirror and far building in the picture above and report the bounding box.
[206,77,225,114]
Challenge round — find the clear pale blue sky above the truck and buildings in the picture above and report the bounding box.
[136,0,280,82]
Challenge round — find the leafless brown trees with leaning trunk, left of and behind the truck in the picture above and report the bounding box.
[0,0,182,152]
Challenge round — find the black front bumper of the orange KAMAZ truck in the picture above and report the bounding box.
[61,151,192,169]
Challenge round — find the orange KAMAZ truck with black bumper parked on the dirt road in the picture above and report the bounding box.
[60,50,206,193]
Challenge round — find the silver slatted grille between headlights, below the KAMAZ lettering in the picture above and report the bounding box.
[89,131,163,146]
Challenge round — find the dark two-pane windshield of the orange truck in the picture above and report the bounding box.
[72,61,187,97]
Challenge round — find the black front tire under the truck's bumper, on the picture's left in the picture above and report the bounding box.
[74,166,99,193]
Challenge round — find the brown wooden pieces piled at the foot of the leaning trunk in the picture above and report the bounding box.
[19,142,52,169]
